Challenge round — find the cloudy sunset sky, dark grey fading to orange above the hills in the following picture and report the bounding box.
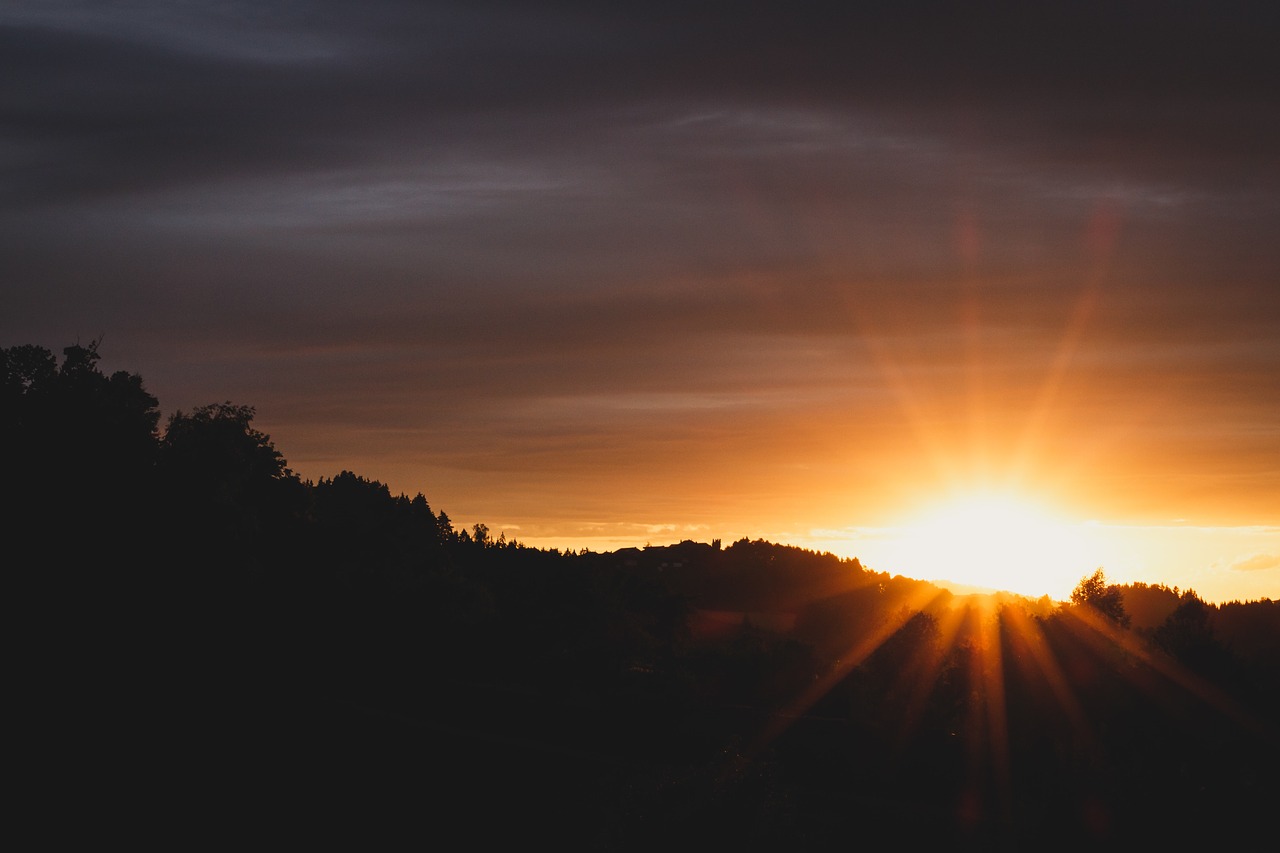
[0,0,1280,601]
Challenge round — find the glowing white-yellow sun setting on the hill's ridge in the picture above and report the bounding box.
[878,491,1097,599]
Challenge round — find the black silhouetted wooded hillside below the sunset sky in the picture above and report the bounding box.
[10,342,1280,850]
